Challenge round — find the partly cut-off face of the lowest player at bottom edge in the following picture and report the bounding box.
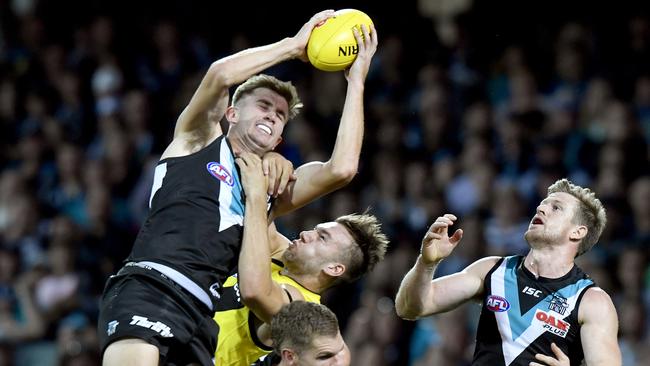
[293,333,350,366]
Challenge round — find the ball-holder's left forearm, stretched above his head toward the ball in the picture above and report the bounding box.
[210,38,300,86]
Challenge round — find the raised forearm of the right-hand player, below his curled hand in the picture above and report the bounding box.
[395,257,438,320]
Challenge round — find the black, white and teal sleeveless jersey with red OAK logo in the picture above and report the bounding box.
[472,256,595,366]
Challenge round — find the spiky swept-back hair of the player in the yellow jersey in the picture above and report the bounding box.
[334,213,389,282]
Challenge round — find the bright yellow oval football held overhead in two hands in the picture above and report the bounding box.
[307,9,372,71]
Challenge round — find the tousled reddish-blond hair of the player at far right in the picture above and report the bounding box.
[548,178,607,257]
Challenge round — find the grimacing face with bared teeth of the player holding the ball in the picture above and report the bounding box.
[232,88,289,152]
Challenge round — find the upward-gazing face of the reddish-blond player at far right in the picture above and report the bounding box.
[525,192,579,244]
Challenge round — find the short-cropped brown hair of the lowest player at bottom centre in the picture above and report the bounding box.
[271,300,339,354]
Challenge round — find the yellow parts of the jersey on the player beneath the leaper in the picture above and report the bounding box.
[214,260,320,366]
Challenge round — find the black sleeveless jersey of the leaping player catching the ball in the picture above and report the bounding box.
[127,136,244,308]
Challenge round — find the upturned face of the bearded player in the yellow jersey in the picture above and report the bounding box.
[284,222,354,271]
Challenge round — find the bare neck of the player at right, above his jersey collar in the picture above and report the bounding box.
[524,247,574,278]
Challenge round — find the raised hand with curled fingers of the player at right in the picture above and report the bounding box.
[420,214,463,264]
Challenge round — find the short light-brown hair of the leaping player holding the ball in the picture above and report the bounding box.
[231,74,303,119]
